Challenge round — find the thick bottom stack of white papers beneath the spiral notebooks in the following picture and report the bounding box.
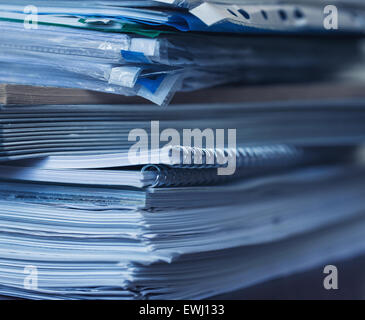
[0,161,365,299]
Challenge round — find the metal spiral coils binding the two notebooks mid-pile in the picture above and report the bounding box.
[142,145,313,187]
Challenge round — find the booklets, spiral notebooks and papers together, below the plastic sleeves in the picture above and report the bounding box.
[0,98,365,299]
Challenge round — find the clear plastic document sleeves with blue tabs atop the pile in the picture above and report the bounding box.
[0,0,365,105]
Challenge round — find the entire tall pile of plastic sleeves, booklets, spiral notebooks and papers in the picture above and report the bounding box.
[0,0,365,299]
